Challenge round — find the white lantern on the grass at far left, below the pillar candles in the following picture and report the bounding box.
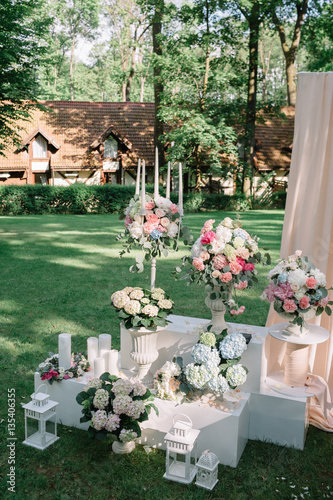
[22,384,59,450]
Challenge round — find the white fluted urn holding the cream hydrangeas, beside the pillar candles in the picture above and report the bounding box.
[128,326,165,388]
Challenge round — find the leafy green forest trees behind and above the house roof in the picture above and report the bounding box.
[0,0,333,193]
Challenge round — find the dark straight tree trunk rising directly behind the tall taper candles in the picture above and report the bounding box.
[153,0,165,166]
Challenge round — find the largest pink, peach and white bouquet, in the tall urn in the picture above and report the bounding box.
[174,217,270,316]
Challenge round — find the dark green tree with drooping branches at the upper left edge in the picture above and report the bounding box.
[0,0,48,155]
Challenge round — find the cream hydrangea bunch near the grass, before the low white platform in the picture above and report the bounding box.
[76,373,158,452]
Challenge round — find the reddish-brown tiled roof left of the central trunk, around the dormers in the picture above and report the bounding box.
[0,101,154,170]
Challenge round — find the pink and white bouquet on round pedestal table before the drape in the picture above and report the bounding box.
[261,250,333,328]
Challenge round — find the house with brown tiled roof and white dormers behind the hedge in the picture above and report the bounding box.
[0,101,294,190]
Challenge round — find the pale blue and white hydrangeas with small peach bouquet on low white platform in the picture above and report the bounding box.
[154,332,248,402]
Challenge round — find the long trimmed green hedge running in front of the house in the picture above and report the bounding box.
[0,184,251,215]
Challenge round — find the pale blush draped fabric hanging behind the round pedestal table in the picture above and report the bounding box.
[265,72,333,427]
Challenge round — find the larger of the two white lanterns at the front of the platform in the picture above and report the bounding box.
[163,413,200,484]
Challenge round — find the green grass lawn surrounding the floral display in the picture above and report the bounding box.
[0,210,333,500]
